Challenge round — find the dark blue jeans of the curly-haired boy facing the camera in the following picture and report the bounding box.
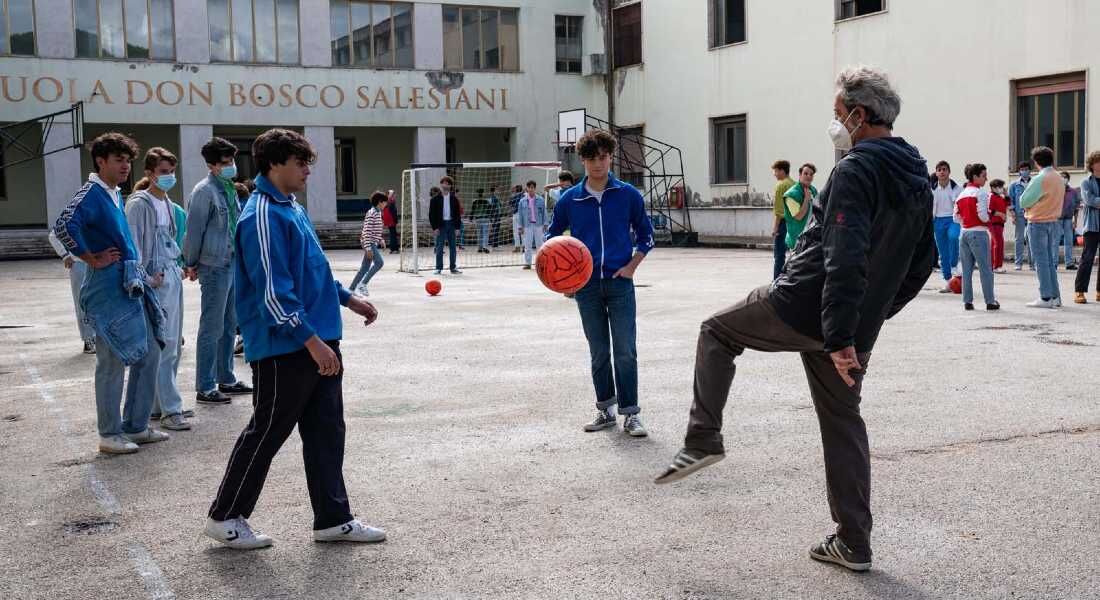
[576,274,639,415]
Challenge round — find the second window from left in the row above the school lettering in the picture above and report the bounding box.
[74,0,176,61]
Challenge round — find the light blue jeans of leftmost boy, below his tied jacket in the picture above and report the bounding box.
[96,310,161,437]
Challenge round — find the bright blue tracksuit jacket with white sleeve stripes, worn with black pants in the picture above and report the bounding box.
[233,175,351,361]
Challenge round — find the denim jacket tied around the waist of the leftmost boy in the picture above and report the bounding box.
[80,261,165,367]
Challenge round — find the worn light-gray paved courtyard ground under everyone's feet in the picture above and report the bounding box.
[0,249,1100,600]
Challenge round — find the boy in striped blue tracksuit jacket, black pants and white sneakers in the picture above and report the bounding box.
[206,129,386,549]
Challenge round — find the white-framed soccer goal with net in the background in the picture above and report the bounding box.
[398,162,561,274]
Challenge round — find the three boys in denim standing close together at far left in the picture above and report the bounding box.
[51,133,252,454]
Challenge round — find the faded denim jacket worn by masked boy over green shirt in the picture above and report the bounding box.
[183,174,237,268]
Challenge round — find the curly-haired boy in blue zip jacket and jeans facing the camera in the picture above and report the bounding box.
[547,130,653,437]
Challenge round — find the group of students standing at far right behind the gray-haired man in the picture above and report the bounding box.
[930,146,1100,310]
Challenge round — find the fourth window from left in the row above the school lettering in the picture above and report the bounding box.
[329,0,414,68]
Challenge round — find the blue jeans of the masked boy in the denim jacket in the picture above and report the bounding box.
[195,264,237,393]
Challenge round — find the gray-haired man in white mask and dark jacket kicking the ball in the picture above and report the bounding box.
[657,67,935,570]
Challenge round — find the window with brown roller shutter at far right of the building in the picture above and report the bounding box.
[1013,73,1086,168]
